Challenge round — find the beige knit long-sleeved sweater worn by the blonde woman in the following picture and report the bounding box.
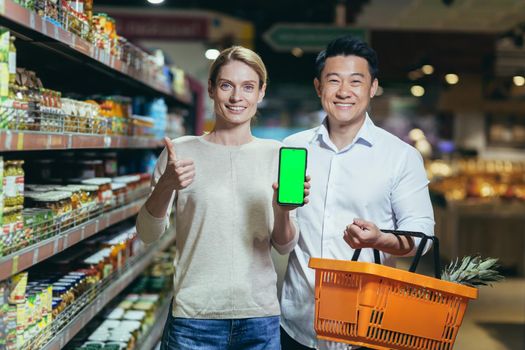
[137,136,299,319]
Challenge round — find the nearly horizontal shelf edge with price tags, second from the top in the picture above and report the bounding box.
[0,130,162,152]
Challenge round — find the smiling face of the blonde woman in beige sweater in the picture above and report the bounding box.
[208,61,266,125]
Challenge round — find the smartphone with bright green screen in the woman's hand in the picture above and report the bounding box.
[277,147,308,206]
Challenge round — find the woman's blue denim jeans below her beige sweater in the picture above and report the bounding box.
[160,308,281,350]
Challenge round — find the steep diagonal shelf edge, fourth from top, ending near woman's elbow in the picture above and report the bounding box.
[39,231,175,350]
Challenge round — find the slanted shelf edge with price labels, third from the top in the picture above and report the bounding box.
[0,198,146,281]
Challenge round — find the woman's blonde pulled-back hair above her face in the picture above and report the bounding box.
[208,46,268,88]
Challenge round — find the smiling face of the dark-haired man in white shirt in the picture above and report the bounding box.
[314,56,378,126]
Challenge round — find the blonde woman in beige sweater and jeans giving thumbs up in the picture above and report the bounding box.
[137,46,309,350]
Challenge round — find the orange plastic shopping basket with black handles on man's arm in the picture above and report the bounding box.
[309,230,478,350]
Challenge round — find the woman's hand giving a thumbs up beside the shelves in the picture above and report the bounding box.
[162,137,195,190]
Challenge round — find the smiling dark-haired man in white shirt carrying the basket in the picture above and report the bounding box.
[281,36,434,350]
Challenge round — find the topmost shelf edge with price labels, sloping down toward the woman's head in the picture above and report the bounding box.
[0,0,192,105]
